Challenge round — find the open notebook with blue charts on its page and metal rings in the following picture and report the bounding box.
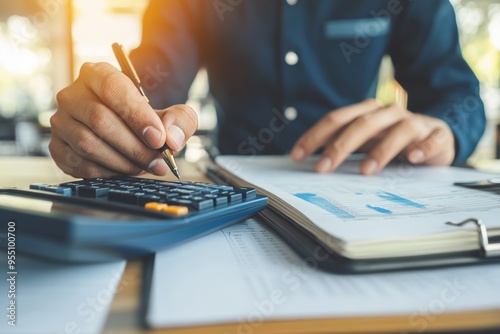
[211,156,500,272]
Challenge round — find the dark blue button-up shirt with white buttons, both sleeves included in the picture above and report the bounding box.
[131,0,485,163]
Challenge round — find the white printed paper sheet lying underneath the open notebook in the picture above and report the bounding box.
[146,220,500,331]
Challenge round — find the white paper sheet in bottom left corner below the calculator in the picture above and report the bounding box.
[0,251,125,334]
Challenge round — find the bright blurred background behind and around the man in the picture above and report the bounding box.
[0,0,500,166]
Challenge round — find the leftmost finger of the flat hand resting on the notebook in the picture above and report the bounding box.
[316,106,408,173]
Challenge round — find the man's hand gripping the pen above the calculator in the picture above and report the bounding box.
[49,63,198,178]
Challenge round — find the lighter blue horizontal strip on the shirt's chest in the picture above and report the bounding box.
[323,17,391,39]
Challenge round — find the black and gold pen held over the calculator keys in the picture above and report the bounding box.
[112,43,181,180]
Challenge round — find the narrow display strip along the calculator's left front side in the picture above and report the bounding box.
[0,194,144,220]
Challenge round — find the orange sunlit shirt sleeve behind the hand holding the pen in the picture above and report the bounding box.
[130,0,202,108]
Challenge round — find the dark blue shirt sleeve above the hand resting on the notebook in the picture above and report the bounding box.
[389,0,486,164]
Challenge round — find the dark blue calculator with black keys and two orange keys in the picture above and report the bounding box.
[0,176,267,262]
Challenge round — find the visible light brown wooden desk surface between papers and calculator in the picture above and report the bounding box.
[0,157,500,334]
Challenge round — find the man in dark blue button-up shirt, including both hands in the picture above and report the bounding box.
[50,0,485,177]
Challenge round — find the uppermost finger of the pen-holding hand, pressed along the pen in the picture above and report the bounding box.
[78,63,166,149]
